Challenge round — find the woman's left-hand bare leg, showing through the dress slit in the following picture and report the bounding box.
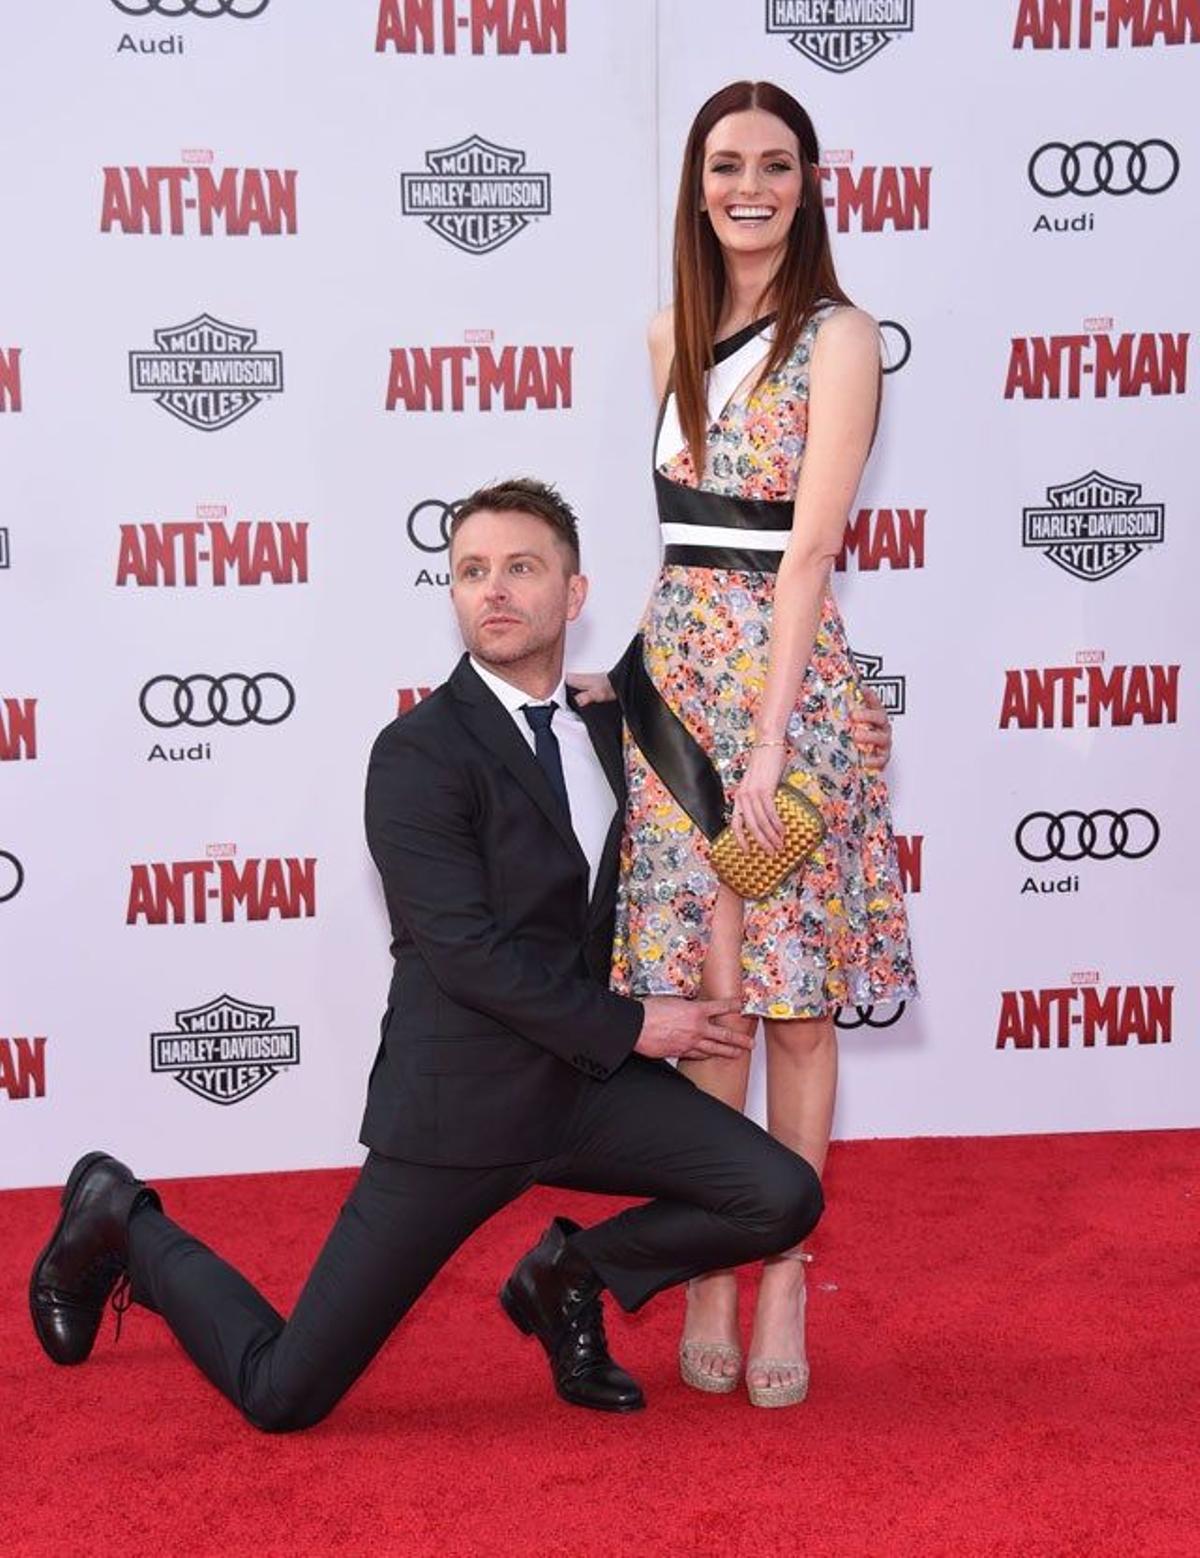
[679,887,757,1379]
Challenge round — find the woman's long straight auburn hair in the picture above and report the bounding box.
[672,81,849,467]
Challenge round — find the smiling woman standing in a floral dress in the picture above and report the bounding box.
[614,81,915,1405]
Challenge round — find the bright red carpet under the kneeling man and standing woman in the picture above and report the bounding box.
[0,1131,1200,1558]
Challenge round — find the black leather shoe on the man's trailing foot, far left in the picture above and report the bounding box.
[30,1153,162,1363]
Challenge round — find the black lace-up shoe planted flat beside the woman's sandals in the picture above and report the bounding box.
[500,1217,645,1412]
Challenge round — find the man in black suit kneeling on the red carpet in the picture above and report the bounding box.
[30,481,821,1430]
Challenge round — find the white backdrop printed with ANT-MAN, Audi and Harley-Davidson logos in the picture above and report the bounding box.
[0,0,1200,1186]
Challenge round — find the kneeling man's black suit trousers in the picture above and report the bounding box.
[129,1056,821,1430]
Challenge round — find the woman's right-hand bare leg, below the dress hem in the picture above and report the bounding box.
[746,1017,837,1388]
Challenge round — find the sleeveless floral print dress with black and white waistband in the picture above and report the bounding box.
[612,305,916,1019]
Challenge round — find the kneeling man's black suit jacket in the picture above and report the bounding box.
[360,656,642,1167]
